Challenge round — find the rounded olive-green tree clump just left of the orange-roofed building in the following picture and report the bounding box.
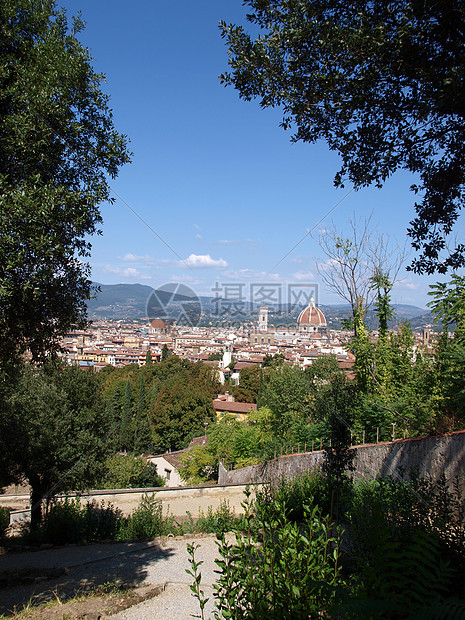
[99,355,220,454]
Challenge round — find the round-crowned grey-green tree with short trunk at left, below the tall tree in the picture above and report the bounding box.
[0,364,111,525]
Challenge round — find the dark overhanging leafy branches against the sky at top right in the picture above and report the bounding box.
[220,0,465,273]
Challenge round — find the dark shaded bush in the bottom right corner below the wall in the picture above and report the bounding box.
[346,477,465,618]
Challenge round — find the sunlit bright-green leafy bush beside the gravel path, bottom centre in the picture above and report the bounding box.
[188,491,342,620]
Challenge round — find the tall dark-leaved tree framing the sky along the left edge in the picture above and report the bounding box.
[0,0,129,366]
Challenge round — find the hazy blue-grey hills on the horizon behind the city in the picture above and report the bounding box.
[87,282,433,329]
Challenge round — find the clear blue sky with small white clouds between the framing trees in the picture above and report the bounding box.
[58,0,463,307]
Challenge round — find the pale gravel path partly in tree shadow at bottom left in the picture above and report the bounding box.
[0,535,225,620]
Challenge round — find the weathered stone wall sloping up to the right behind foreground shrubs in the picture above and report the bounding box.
[219,431,465,492]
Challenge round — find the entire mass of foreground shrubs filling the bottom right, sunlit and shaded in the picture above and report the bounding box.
[187,471,465,620]
